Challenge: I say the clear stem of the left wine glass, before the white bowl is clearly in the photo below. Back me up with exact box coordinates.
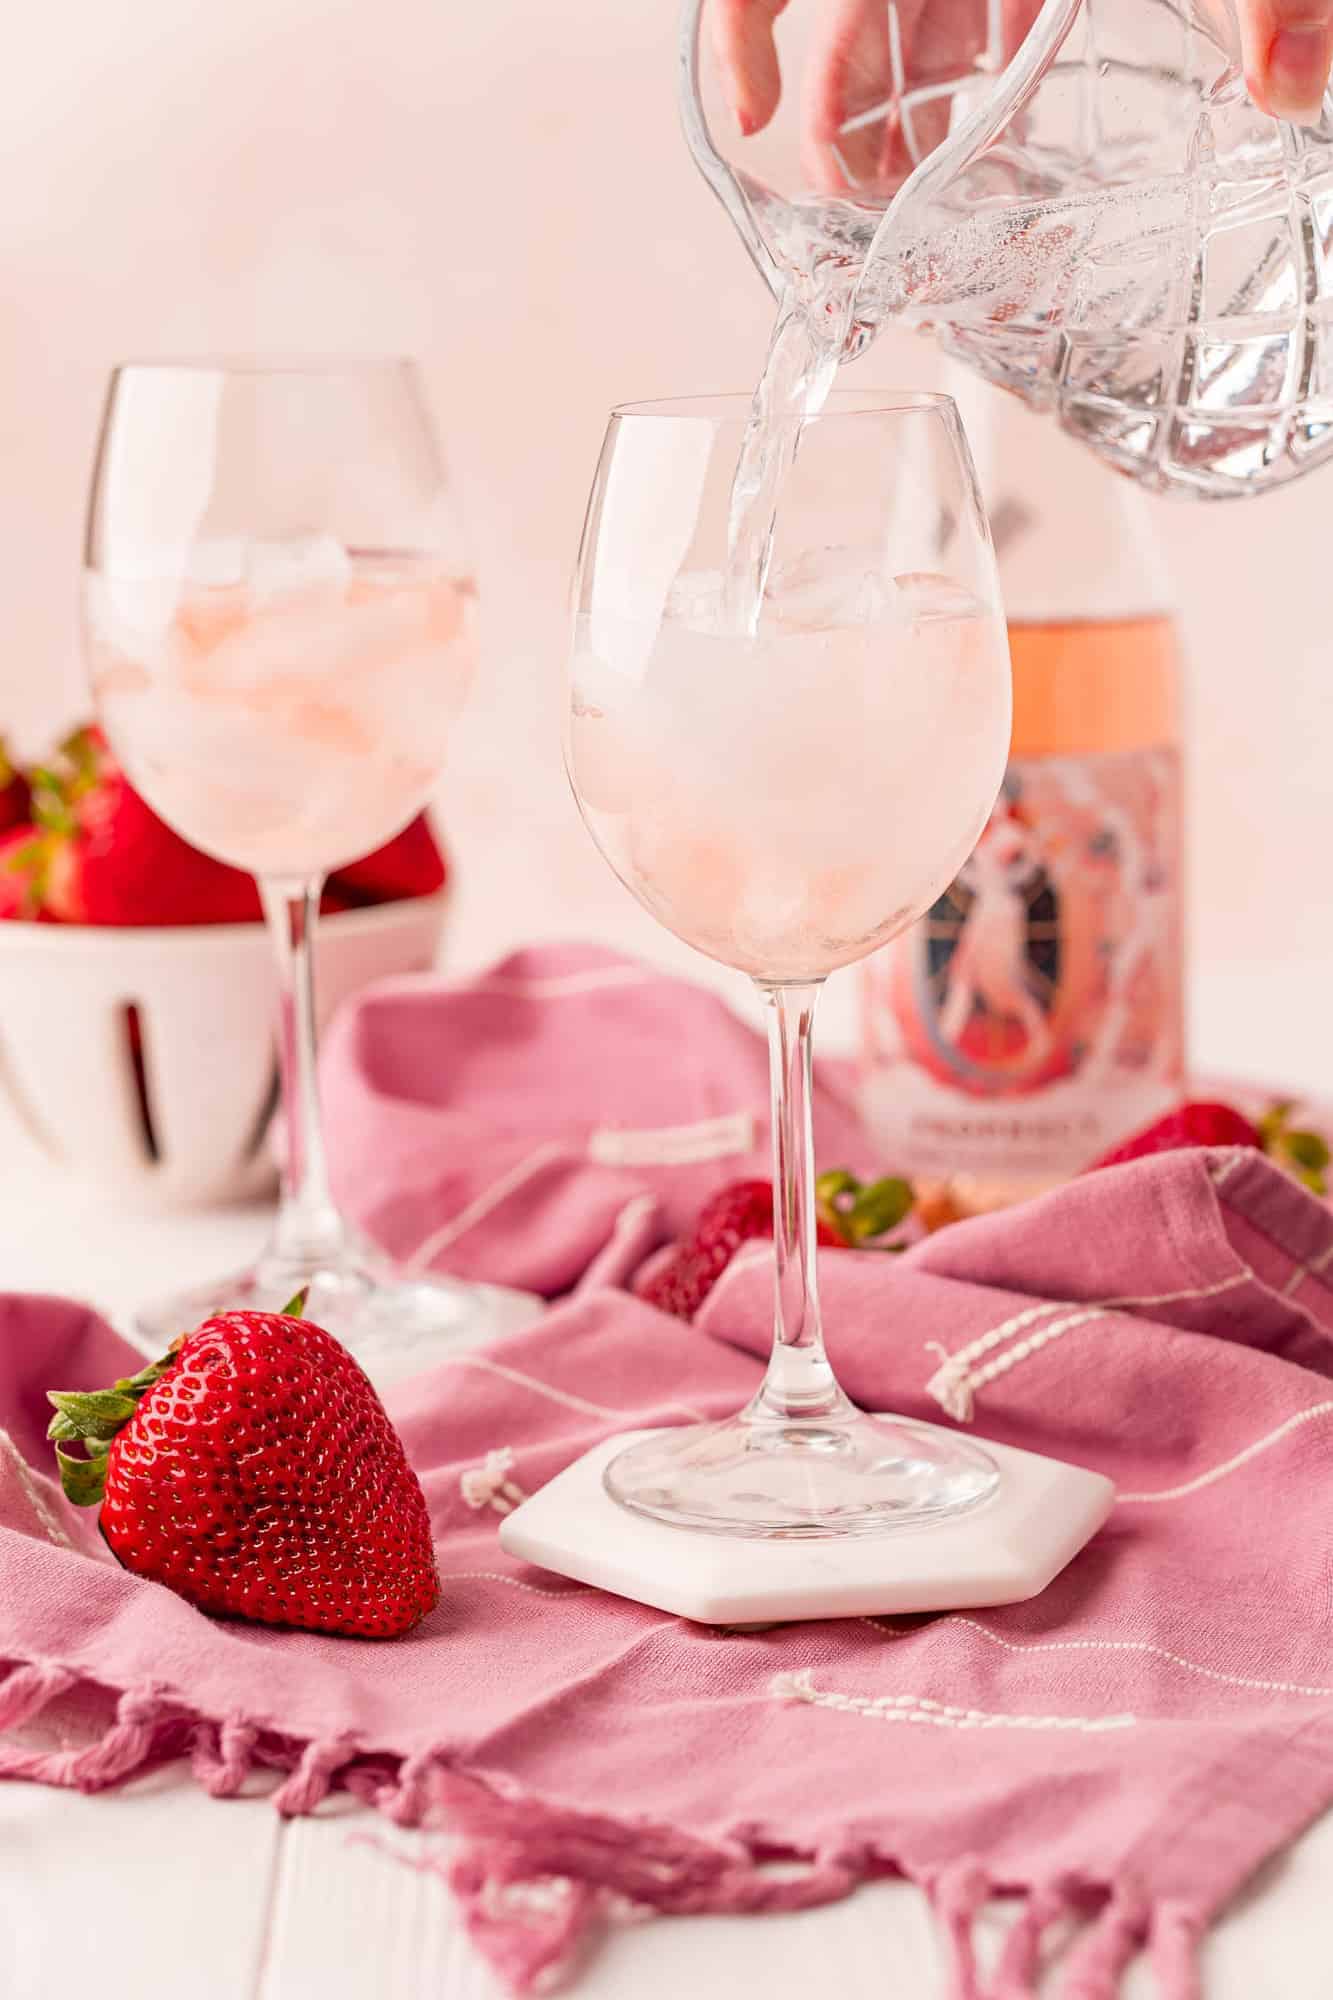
[260,876,346,1270]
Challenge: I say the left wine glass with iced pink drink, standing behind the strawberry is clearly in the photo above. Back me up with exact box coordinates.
[84,360,528,1376]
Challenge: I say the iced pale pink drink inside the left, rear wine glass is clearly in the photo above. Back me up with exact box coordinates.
[84,556,474,878]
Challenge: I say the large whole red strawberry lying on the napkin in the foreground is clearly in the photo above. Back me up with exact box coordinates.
[48,1298,440,1638]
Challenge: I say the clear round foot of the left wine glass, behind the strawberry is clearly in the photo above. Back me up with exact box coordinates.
[134,1246,542,1388]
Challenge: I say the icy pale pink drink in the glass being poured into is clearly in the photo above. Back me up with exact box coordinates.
[566,580,1011,980]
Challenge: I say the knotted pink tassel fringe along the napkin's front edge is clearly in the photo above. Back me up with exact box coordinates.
[0,1660,1203,2000]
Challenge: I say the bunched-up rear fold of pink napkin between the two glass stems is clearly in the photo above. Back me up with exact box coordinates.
[322,946,875,1298]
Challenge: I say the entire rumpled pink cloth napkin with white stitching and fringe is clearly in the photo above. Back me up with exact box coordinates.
[0,952,1333,2000]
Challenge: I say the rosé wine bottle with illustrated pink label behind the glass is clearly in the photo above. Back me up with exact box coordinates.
[863,374,1185,1212]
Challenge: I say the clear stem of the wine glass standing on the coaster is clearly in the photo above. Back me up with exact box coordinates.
[745,984,851,1422]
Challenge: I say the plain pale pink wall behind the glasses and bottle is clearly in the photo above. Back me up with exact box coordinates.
[0,0,1333,1074]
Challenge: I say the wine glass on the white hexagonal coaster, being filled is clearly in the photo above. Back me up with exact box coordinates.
[566,392,1011,1536]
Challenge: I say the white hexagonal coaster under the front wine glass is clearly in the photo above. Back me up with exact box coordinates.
[500,1430,1115,1626]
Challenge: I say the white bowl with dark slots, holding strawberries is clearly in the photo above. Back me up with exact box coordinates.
[0,892,448,1208]
